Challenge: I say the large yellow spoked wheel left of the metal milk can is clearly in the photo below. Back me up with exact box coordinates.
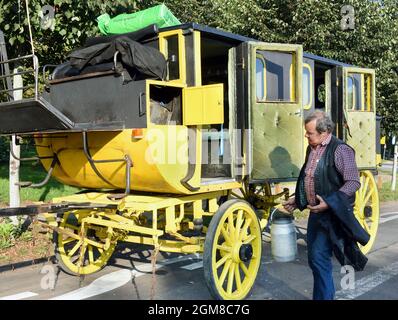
[203,199,261,300]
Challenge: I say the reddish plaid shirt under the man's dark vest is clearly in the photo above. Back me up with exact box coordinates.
[304,134,361,206]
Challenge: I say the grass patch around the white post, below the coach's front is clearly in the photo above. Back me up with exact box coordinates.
[0,163,80,205]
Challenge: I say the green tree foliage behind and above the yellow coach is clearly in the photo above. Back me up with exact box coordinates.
[0,0,398,132]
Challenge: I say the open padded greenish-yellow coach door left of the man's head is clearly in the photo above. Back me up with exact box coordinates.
[248,42,304,180]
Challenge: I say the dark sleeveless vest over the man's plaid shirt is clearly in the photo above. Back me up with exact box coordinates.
[295,136,355,210]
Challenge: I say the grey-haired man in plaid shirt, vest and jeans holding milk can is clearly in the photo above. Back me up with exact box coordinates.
[283,111,366,300]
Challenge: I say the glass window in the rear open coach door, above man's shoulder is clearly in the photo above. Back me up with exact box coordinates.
[347,73,373,111]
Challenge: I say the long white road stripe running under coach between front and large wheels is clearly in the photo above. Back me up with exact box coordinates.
[50,254,200,300]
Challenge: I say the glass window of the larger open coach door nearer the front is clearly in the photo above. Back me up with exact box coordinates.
[256,50,296,102]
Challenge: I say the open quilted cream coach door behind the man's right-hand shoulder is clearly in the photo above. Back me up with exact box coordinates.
[342,67,376,168]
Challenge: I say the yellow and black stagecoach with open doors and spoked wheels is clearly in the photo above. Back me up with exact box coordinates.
[0,23,379,299]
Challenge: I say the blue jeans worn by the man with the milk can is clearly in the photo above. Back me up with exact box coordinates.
[307,213,335,300]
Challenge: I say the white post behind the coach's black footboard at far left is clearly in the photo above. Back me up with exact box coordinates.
[10,68,23,225]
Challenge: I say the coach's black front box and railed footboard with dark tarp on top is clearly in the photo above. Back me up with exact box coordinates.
[0,25,167,135]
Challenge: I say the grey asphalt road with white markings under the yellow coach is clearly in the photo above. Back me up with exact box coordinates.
[0,202,398,300]
